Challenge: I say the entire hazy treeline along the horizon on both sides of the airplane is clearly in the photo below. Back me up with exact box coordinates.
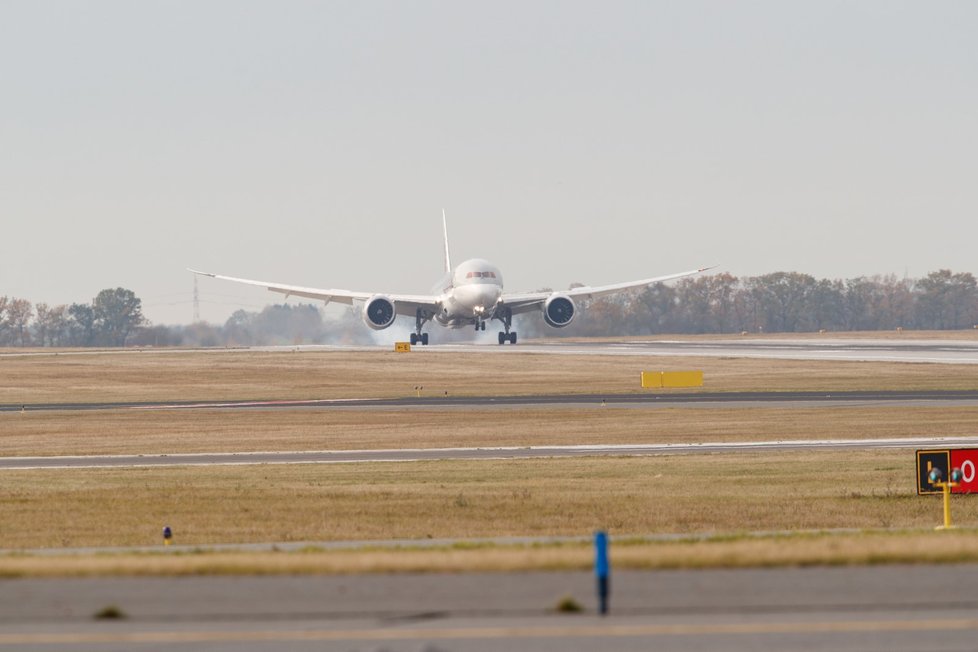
[0,270,978,347]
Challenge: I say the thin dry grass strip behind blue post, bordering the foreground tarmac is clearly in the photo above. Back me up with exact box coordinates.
[0,530,978,577]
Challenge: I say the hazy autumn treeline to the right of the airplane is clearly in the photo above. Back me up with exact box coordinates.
[520,269,978,337]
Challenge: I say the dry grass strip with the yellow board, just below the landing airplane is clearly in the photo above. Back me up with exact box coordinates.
[0,350,978,404]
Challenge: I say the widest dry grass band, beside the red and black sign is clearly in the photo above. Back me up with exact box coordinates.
[0,451,960,548]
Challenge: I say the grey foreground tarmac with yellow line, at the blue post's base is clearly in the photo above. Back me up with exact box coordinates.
[0,564,978,652]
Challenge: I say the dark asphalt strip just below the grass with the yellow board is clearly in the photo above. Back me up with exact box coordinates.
[0,390,978,412]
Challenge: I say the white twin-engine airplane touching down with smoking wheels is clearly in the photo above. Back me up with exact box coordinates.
[188,211,712,345]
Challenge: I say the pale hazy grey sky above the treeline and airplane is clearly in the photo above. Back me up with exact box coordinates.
[0,0,978,323]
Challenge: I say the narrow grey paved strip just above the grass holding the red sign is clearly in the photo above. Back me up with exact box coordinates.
[7,437,978,471]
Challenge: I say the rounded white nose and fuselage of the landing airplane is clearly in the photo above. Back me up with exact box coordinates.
[435,258,503,328]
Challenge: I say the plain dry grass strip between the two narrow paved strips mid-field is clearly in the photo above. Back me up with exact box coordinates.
[0,404,978,456]
